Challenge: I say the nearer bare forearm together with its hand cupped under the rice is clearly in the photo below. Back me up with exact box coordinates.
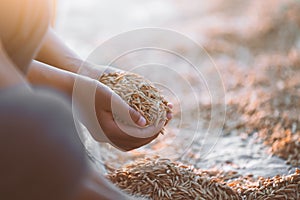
[27,61,162,150]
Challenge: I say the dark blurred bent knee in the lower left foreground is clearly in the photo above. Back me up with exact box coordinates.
[0,88,87,200]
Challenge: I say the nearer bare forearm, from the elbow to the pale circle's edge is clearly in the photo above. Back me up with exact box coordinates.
[27,61,77,96]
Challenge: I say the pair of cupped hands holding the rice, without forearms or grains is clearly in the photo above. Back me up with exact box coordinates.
[77,65,172,151]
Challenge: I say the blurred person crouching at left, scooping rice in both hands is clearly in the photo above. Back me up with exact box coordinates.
[0,0,171,200]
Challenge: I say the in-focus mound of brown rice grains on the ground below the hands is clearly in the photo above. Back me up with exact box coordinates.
[107,158,240,200]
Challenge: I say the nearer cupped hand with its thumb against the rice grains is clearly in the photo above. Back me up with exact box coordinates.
[95,83,169,151]
